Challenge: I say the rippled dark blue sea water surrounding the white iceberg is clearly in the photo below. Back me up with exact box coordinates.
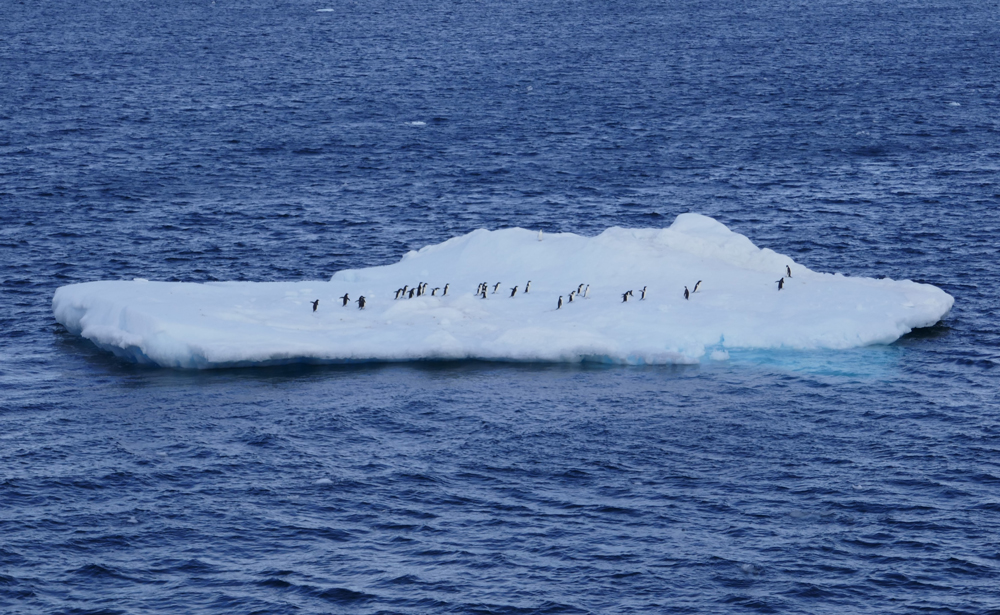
[0,0,1000,615]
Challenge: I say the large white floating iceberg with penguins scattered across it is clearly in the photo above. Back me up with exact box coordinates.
[52,214,954,368]
